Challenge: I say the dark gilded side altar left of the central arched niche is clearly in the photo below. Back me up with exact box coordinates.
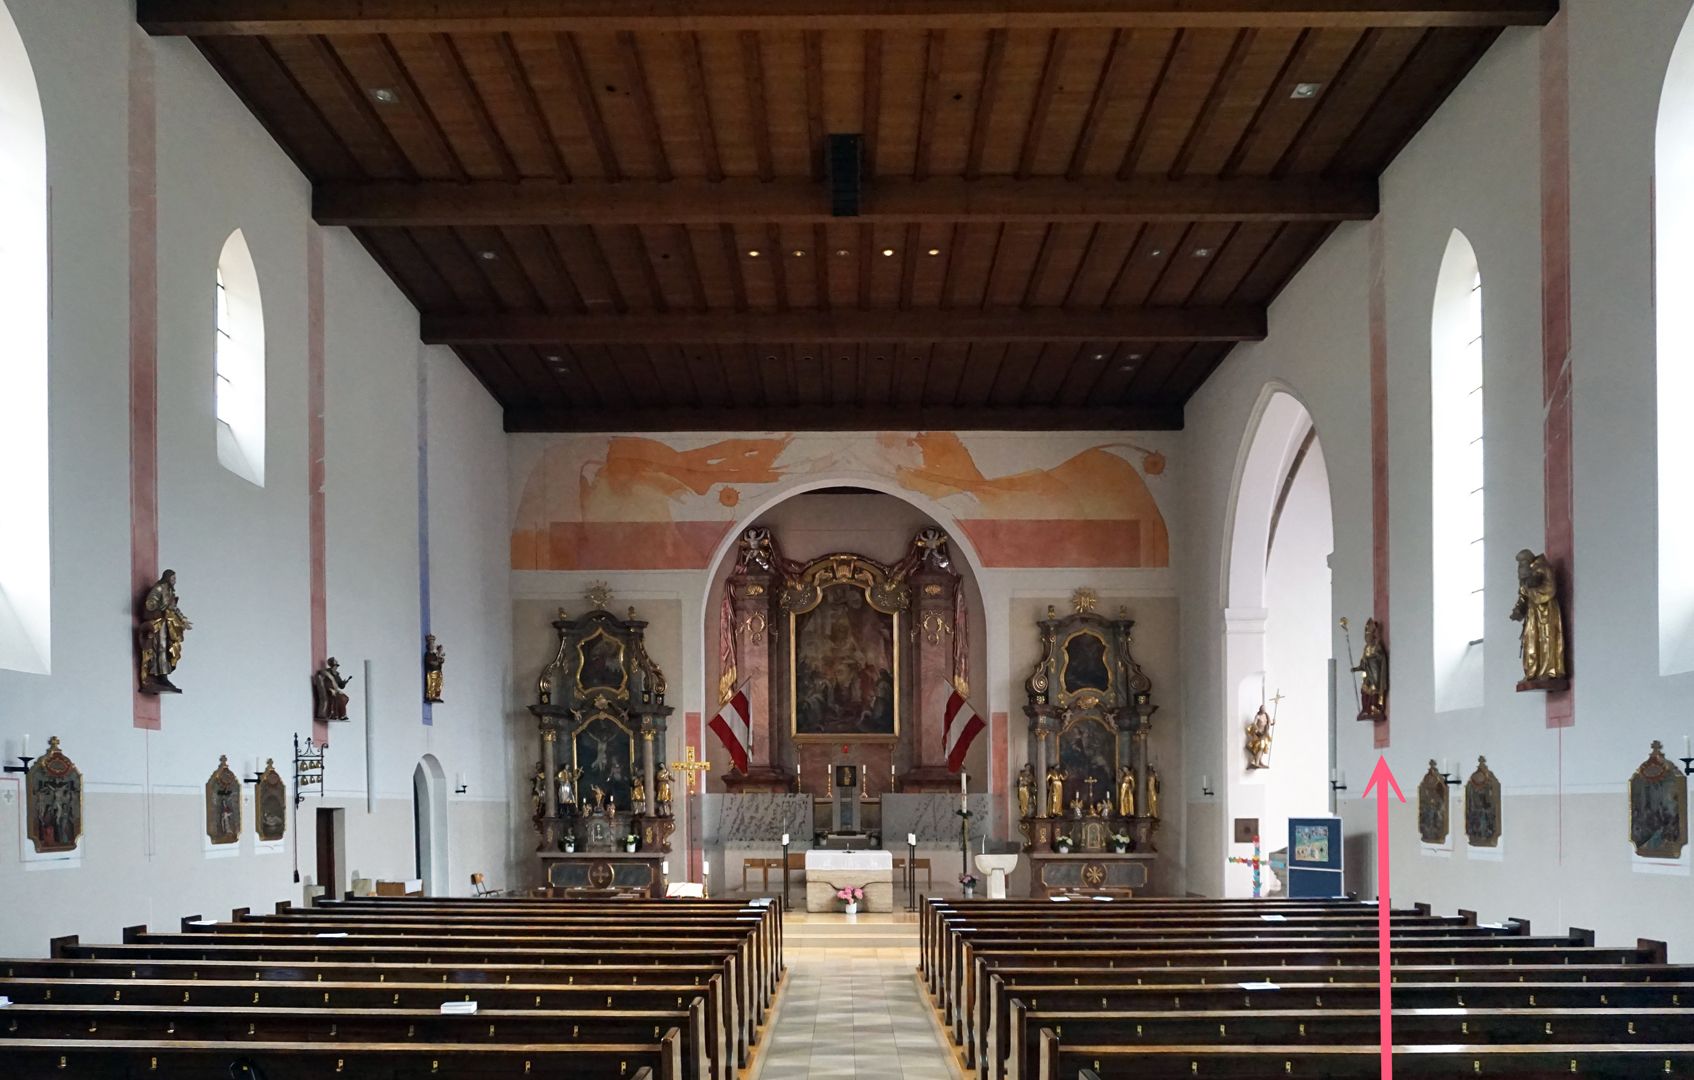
[529,587,676,895]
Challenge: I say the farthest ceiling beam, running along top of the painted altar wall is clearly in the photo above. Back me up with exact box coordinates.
[505,405,1182,432]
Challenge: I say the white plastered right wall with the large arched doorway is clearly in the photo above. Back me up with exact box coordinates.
[1182,0,1694,956]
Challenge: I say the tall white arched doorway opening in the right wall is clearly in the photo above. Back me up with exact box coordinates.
[1220,386,1335,895]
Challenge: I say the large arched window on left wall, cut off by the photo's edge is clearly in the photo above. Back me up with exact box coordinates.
[0,0,53,674]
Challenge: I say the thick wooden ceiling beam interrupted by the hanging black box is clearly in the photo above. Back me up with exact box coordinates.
[312,176,1377,227]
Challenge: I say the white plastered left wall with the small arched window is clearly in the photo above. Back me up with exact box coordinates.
[0,0,512,955]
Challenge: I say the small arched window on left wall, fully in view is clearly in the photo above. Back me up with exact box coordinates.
[215,229,264,488]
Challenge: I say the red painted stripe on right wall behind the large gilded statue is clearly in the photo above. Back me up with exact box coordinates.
[1542,12,1577,728]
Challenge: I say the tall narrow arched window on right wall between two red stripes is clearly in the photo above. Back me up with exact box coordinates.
[1430,229,1486,709]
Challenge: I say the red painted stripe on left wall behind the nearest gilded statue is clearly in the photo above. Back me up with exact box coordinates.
[129,29,163,731]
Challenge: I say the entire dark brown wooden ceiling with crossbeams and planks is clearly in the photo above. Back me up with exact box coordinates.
[137,0,1557,430]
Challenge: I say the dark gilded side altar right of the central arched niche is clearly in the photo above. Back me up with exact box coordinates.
[1018,589,1159,897]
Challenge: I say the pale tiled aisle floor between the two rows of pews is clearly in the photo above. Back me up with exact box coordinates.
[750,912,957,1080]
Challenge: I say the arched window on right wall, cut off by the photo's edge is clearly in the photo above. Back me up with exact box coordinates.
[1653,19,1694,675]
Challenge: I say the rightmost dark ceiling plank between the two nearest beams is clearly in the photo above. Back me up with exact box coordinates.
[1325,29,1497,176]
